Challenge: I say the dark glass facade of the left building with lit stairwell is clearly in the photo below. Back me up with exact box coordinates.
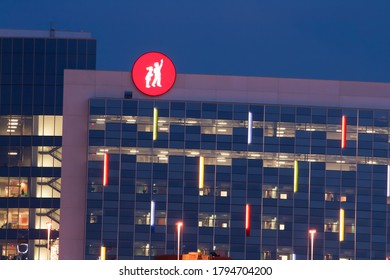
[0,36,96,259]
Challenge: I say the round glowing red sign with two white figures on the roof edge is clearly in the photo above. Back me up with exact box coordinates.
[131,52,176,96]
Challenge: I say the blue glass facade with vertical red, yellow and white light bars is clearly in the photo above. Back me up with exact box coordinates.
[85,98,390,260]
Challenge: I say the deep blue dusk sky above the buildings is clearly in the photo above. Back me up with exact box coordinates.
[0,0,390,82]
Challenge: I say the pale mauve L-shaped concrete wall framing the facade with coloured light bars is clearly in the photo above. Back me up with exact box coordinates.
[60,70,390,259]
